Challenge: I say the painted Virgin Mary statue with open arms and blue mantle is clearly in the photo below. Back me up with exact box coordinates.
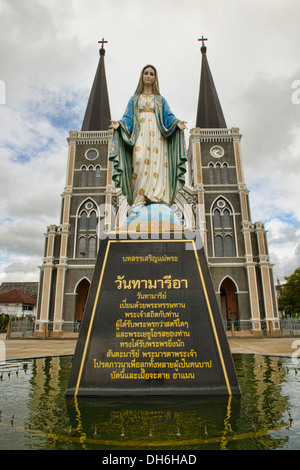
[109,65,187,206]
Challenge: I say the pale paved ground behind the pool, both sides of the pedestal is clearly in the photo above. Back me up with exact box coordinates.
[0,334,300,360]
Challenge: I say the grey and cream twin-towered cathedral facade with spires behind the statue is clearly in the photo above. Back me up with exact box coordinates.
[36,44,280,335]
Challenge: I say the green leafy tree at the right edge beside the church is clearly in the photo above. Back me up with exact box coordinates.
[278,268,300,317]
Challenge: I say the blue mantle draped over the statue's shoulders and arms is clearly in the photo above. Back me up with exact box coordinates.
[109,95,187,205]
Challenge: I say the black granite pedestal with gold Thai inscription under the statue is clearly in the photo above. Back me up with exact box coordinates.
[66,233,240,397]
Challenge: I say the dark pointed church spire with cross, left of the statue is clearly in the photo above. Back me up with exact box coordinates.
[81,39,111,131]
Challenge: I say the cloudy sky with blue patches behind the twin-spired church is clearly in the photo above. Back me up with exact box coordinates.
[0,0,300,283]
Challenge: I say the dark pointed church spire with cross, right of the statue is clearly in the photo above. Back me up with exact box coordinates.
[196,36,227,129]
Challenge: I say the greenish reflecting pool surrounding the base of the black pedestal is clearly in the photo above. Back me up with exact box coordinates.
[0,354,300,451]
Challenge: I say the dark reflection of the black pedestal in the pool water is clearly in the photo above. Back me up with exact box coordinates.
[68,397,237,448]
